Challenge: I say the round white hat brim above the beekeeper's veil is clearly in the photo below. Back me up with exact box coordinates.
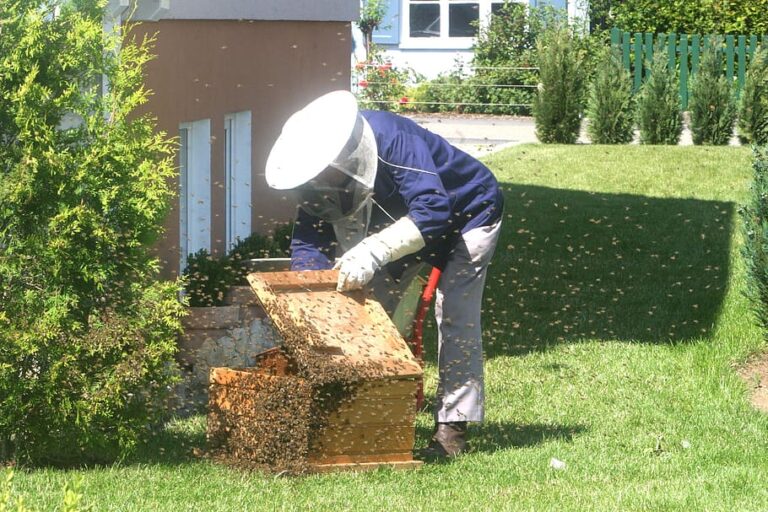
[266,91,358,190]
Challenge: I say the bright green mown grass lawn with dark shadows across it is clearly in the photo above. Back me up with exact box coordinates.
[6,145,768,512]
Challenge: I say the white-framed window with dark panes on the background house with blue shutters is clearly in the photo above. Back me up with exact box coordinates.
[403,0,516,48]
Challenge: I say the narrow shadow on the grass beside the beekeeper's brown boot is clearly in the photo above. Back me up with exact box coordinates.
[416,422,587,453]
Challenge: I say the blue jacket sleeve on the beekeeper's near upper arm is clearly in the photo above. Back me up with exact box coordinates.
[382,134,451,244]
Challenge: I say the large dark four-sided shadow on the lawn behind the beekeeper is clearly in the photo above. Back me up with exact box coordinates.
[425,184,735,360]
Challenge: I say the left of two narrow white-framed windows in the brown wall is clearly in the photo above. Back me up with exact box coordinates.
[179,119,211,271]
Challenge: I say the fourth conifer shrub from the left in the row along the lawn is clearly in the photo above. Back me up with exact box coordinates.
[688,38,736,146]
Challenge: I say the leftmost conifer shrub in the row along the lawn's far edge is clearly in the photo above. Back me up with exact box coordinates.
[533,27,586,144]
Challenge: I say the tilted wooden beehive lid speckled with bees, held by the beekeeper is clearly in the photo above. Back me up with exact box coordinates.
[248,270,422,380]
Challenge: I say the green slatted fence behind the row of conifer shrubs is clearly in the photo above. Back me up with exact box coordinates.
[611,28,768,108]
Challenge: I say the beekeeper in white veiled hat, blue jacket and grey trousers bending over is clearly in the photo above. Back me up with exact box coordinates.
[266,91,503,457]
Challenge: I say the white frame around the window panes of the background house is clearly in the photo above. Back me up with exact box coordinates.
[400,0,512,50]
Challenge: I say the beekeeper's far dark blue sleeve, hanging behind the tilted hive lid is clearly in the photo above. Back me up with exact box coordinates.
[291,208,336,270]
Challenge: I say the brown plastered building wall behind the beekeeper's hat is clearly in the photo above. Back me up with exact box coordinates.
[132,19,351,277]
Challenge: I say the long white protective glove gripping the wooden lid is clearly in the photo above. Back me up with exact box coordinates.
[333,217,425,292]
